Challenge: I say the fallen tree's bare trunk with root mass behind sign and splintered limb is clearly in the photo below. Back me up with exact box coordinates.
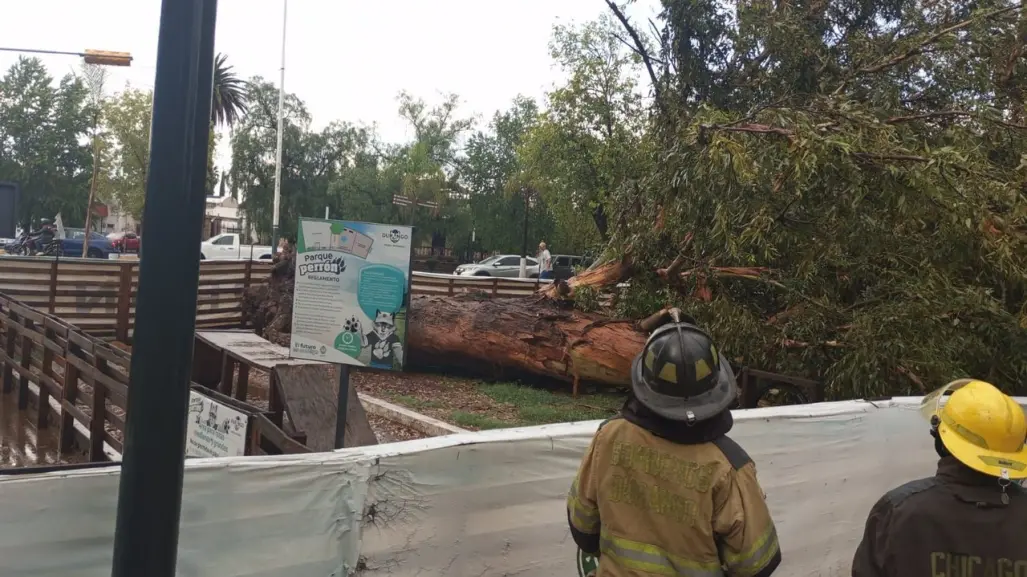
[242,251,646,391]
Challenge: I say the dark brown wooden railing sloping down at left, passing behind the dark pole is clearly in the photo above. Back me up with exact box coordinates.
[0,295,306,462]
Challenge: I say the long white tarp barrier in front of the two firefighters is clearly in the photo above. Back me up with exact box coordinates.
[0,399,1022,577]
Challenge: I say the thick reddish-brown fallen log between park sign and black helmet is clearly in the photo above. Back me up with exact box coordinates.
[407,295,645,389]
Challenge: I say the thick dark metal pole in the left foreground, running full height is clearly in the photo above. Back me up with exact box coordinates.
[112,0,217,577]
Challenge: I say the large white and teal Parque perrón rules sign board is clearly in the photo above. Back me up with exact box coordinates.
[290,219,413,371]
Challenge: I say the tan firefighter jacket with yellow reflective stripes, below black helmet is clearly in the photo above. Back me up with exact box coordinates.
[567,399,781,577]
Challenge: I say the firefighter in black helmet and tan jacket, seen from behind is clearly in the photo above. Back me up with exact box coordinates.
[567,311,781,577]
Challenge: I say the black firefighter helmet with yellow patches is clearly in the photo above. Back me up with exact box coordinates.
[632,322,738,424]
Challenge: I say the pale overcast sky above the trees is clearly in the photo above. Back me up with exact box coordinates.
[0,0,656,142]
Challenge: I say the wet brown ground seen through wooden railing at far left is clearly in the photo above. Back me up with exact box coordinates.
[0,393,62,468]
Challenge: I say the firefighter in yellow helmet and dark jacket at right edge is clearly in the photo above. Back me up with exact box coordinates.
[852,379,1027,577]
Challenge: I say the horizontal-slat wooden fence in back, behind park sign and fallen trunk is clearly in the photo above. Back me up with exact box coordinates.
[0,256,548,342]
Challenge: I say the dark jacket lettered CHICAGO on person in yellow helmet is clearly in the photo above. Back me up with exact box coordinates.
[852,456,1027,577]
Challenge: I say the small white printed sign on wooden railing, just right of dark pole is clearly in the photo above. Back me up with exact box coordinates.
[186,390,250,457]
